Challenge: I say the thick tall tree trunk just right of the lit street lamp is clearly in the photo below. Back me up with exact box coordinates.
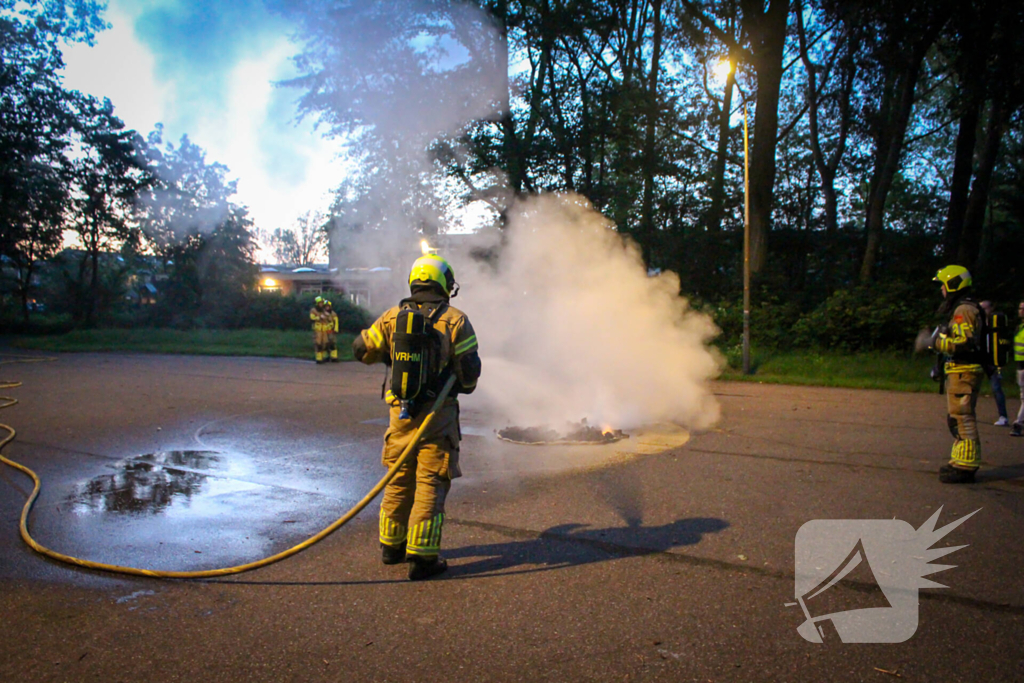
[740,0,790,274]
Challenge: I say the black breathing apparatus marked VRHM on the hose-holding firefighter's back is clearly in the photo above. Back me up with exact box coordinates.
[391,303,446,420]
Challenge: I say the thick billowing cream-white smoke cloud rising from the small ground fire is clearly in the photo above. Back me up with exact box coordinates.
[454,195,722,428]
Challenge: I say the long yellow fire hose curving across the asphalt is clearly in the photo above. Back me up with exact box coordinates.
[0,357,456,579]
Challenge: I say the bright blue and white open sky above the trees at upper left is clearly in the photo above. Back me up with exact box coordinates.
[65,0,352,235]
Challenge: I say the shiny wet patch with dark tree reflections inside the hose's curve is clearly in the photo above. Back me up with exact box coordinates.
[34,451,364,570]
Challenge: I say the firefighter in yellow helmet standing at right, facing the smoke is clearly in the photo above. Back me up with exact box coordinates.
[933,265,986,483]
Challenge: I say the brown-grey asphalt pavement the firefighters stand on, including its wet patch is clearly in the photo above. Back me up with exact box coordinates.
[0,354,1024,683]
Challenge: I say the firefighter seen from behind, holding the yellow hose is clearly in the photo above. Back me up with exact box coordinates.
[352,254,480,581]
